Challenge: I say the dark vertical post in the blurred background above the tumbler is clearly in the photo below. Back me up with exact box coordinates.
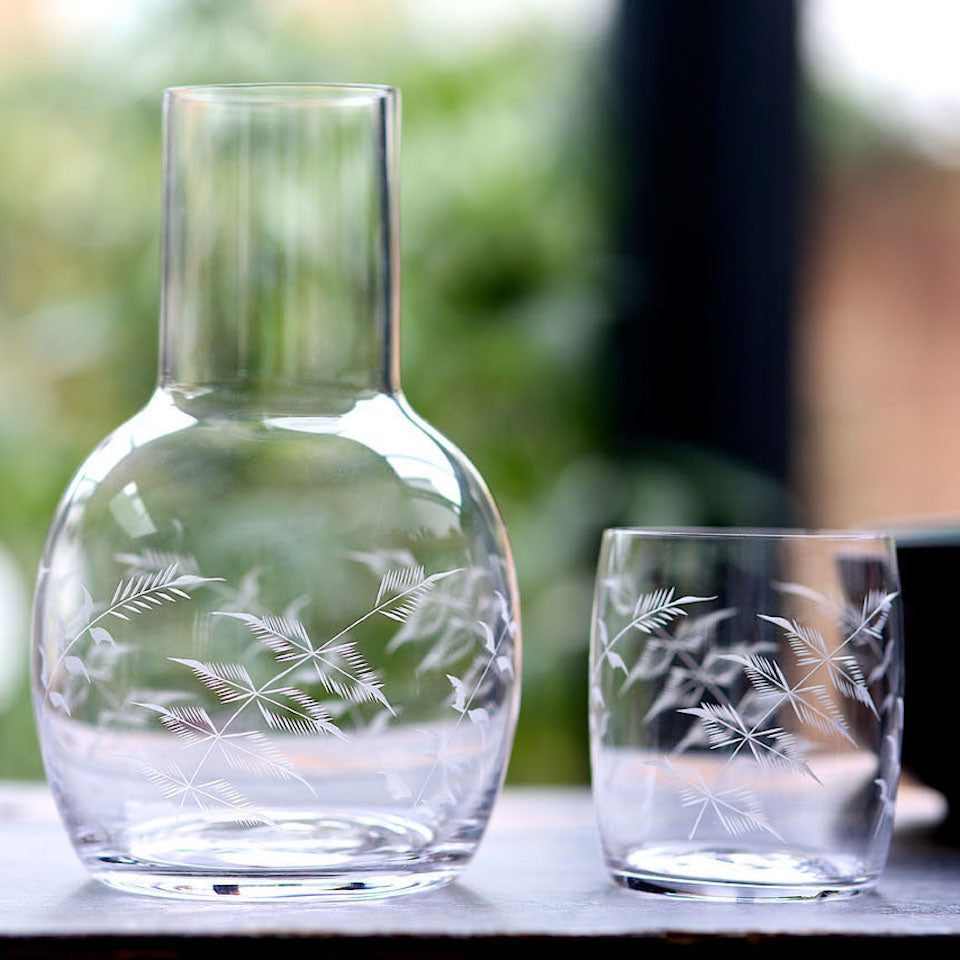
[612,0,799,510]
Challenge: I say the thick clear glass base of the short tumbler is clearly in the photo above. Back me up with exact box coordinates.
[609,845,876,902]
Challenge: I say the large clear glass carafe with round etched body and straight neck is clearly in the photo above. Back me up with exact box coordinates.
[33,84,520,899]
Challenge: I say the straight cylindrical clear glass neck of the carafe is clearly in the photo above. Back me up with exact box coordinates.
[160,84,400,402]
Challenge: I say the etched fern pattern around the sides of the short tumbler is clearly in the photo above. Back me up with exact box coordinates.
[590,582,902,840]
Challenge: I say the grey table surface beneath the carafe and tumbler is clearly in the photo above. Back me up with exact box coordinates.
[0,784,960,957]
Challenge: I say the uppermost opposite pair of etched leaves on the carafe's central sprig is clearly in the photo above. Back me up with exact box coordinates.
[213,610,392,710]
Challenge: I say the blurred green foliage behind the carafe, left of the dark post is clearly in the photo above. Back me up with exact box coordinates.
[0,0,619,782]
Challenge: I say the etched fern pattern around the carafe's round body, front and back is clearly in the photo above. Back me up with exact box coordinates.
[40,550,516,825]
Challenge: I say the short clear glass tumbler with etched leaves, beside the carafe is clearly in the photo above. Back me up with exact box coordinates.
[590,529,903,900]
